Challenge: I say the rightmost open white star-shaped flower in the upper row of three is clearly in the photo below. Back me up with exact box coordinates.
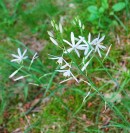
[92,35,106,57]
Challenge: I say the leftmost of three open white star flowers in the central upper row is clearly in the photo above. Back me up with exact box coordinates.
[63,32,84,57]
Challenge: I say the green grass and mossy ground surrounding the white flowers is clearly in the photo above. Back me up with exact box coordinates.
[0,0,130,133]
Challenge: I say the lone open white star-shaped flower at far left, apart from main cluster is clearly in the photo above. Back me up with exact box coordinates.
[11,48,28,63]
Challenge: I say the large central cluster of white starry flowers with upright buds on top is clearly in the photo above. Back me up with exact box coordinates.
[48,18,111,83]
